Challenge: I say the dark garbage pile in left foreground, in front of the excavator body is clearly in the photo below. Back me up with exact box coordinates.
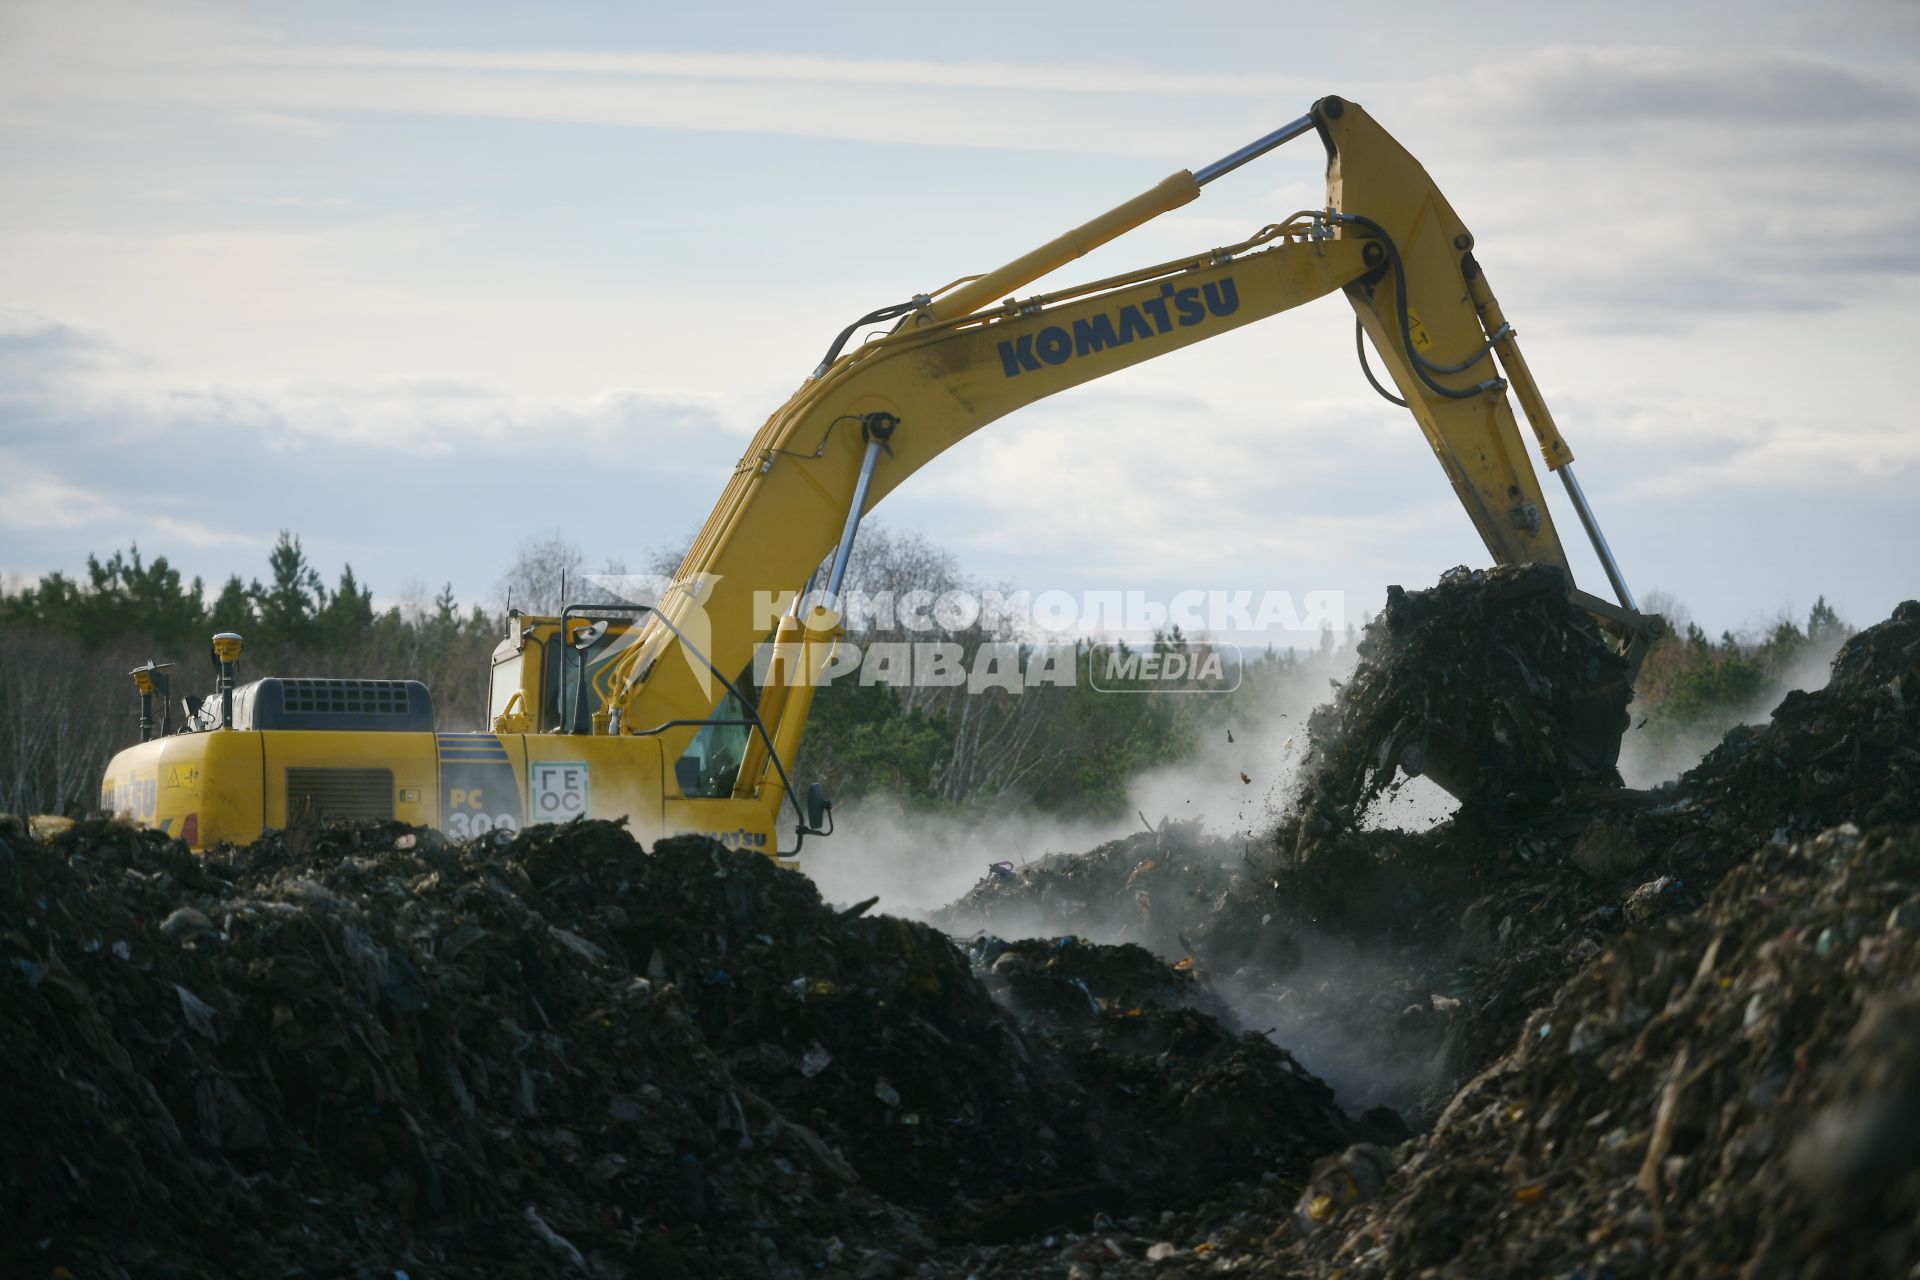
[0,819,1382,1276]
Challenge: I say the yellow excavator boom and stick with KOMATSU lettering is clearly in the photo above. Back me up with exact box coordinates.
[595,98,1642,844]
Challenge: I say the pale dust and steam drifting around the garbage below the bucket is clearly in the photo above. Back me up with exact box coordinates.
[803,614,1841,1111]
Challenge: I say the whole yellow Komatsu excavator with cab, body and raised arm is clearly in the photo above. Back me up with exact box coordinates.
[102,96,1661,858]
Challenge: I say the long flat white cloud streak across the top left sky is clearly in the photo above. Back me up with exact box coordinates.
[0,6,1311,154]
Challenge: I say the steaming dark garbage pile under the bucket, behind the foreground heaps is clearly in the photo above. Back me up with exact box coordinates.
[935,594,1920,1125]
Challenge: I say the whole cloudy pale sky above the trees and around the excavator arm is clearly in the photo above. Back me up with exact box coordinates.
[0,0,1920,629]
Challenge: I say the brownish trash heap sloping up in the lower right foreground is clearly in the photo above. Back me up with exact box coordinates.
[1282,825,1920,1278]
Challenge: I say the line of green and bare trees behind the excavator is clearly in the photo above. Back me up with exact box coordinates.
[0,526,1849,818]
